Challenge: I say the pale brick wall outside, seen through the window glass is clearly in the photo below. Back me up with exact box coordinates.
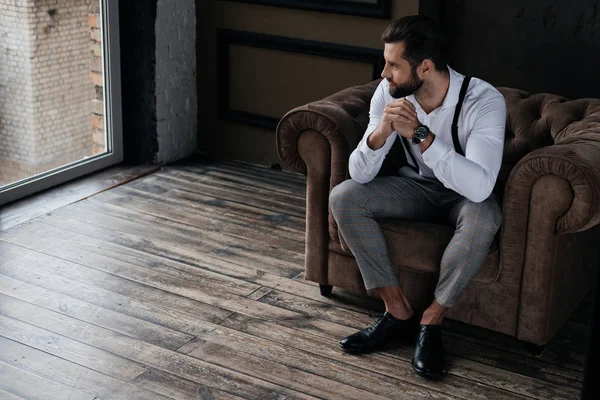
[0,0,98,184]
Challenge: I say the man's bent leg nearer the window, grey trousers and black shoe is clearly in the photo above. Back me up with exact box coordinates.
[329,177,435,352]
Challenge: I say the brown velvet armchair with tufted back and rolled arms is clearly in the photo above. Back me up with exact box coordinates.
[276,81,600,345]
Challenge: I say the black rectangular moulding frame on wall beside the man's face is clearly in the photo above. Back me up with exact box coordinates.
[217,29,385,129]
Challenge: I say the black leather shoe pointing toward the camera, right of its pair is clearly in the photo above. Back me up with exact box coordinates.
[412,325,444,378]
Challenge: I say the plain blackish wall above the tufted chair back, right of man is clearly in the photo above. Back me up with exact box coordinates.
[441,0,600,98]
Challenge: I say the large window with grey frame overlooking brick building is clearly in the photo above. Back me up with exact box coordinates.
[0,0,123,205]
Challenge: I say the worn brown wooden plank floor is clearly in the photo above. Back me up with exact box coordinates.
[0,163,589,400]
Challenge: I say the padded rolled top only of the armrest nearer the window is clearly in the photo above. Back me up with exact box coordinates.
[276,81,379,188]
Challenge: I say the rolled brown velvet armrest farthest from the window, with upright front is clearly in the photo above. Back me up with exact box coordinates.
[500,138,600,344]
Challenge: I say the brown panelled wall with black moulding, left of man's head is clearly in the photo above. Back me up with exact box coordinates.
[196,0,422,166]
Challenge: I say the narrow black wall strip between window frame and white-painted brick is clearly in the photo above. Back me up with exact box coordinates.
[119,0,158,164]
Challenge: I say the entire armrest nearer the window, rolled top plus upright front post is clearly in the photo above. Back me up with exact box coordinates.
[276,81,379,284]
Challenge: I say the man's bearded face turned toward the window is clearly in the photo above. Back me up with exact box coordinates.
[381,42,423,99]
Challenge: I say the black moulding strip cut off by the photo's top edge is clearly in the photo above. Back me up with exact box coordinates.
[227,0,392,19]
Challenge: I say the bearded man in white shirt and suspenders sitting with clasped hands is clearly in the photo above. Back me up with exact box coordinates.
[329,16,506,377]
